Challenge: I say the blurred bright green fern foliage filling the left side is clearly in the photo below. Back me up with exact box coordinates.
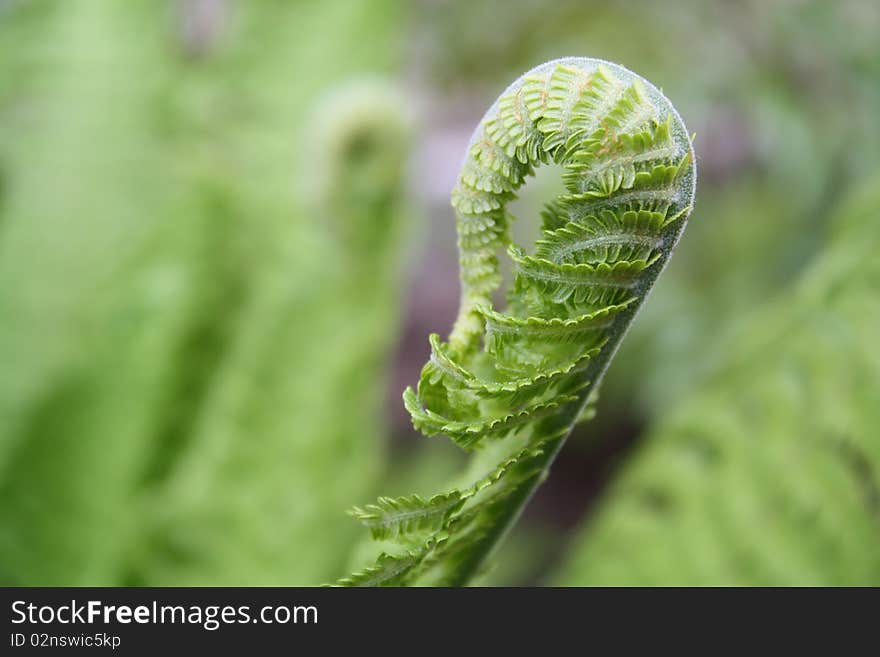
[0,0,407,585]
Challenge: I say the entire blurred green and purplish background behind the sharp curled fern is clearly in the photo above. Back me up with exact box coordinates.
[0,0,880,585]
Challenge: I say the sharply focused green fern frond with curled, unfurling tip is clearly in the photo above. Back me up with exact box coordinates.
[339,58,696,585]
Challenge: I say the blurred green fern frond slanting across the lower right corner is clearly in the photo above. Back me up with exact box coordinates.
[557,176,880,585]
